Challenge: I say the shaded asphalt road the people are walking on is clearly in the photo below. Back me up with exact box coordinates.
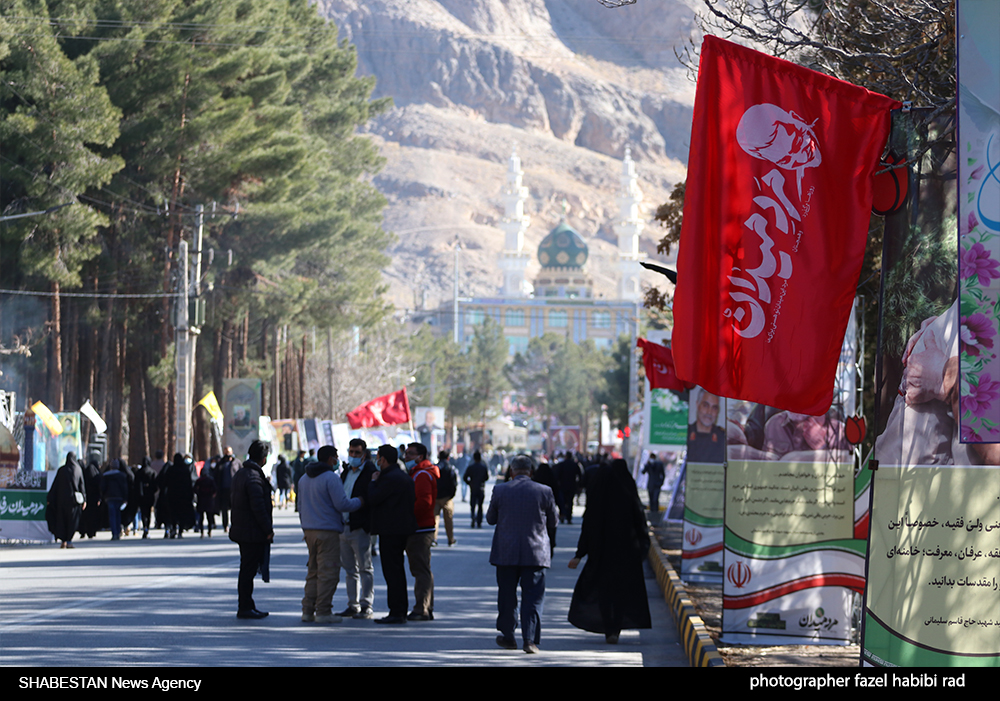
[0,482,687,667]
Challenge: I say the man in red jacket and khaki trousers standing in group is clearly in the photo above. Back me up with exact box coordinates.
[403,443,441,621]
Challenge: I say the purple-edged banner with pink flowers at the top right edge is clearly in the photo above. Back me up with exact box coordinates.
[958,0,1000,443]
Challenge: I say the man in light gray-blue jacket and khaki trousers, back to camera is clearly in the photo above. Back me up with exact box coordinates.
[295,445,364,623]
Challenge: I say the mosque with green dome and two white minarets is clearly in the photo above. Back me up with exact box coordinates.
[456,148,645,355]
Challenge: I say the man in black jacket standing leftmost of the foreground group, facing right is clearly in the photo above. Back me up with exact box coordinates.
[229,441,274,619]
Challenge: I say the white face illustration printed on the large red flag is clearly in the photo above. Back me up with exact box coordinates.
[736,103,823,173]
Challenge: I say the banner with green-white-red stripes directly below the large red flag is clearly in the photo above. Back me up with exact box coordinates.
[722,318,869,645]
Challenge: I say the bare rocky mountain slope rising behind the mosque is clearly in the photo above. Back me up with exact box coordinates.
[318,0,698,309]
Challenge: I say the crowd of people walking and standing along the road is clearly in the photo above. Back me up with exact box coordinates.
[47,439,649,653]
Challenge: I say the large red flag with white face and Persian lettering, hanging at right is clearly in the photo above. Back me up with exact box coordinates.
[673,36,900,415]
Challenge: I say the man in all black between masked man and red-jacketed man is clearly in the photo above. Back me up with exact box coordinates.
[367,445,417,624]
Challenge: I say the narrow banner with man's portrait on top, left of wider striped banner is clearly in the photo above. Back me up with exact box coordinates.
[681,387,726,582]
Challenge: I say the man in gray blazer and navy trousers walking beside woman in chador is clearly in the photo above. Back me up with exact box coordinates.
[486,455,556,653]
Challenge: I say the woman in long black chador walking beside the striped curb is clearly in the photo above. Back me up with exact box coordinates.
[569,460,652,643]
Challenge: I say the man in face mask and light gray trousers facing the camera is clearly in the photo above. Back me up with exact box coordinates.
[340,438,376,618]
